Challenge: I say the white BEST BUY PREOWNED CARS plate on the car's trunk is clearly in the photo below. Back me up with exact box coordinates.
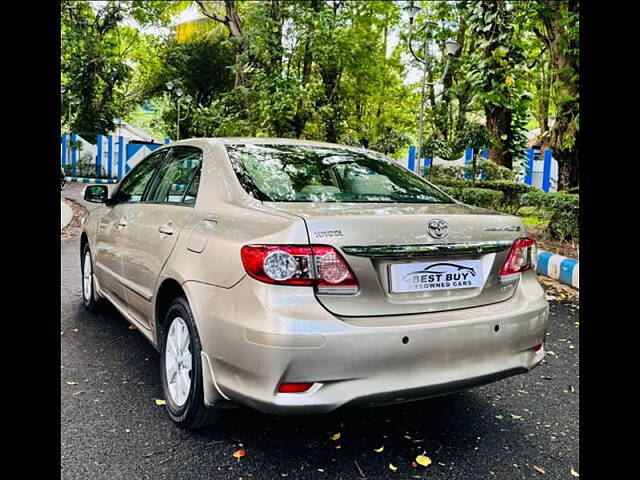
[389,260,484,293]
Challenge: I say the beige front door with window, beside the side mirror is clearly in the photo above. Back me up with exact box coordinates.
[93,150,166,306]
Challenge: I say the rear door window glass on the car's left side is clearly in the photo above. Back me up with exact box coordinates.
[146,147,202,205]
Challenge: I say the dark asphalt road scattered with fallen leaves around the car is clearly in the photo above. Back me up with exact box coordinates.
[61,185,579,480]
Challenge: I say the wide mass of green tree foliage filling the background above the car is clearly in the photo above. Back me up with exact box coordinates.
[61,0,579,180]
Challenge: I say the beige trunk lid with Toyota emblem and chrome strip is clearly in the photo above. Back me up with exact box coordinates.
[265,202,523,316]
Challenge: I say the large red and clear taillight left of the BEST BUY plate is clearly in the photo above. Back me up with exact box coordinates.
[240,245,358,295]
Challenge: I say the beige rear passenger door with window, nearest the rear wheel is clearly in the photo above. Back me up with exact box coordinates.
[123,146,202,328]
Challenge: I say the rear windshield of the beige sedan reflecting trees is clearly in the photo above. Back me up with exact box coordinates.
[227,145,453,203]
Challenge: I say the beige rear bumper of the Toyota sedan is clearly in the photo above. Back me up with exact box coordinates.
[182,272,548,414]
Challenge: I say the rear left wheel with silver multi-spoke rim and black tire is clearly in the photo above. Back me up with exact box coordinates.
[160,297,220,429]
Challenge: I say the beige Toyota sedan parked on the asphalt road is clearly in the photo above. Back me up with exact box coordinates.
[81,138,548,428]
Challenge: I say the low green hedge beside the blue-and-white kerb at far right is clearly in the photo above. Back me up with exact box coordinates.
[524,190,580,240]
